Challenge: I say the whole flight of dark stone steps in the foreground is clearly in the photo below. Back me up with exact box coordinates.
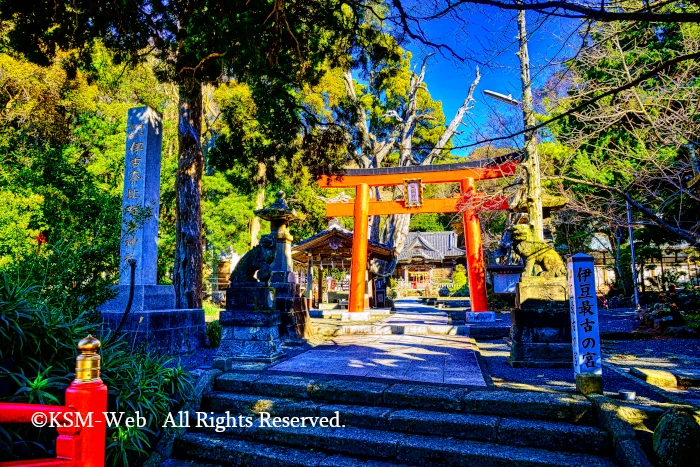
[163,372,616,467]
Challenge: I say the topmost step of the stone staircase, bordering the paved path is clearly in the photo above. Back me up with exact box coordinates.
[215,372,594,423]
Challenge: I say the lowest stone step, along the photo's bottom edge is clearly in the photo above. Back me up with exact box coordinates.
[175,427,615,467]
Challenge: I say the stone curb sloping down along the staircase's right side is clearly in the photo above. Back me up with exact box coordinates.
[586,394,652,467]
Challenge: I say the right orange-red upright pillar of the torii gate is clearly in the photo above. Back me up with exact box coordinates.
[461,178,489,311]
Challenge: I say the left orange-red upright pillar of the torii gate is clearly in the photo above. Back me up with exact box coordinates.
[348,183,369,313]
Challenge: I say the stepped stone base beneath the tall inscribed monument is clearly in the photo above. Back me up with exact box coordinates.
[100,285,205,355]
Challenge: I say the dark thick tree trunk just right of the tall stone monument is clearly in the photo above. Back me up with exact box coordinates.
[173,83,204,309]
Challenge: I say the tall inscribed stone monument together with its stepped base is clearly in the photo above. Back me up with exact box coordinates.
[100,107,205,354]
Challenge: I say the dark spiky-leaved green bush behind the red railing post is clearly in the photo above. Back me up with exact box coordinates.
[0,274,192,466]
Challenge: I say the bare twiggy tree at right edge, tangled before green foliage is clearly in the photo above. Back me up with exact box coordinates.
[549,18,700,247]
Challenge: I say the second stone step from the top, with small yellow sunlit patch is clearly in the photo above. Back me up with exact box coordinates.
[203,392,610,454]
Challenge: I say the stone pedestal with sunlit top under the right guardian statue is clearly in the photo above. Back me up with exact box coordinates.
[507,277,571,368]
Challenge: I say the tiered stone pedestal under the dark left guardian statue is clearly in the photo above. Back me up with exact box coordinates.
[213,282,284,370]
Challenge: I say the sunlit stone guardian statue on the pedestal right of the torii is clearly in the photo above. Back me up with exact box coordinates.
[510,224,566,277]
